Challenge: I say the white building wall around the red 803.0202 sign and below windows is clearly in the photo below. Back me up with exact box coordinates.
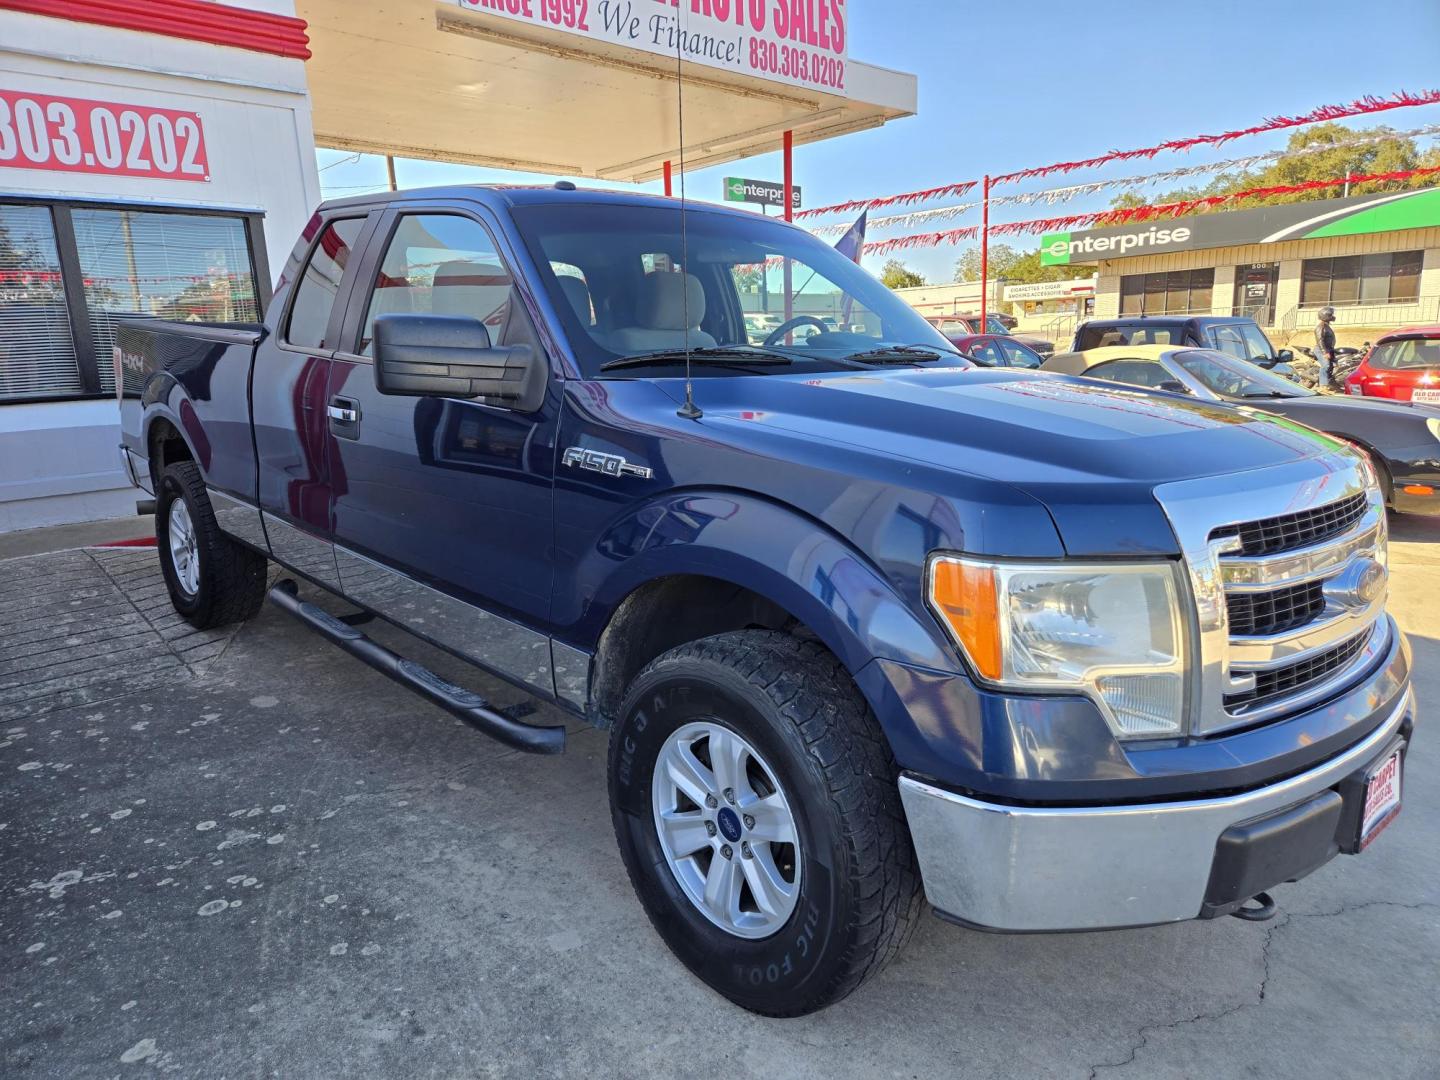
[0,8,321,531]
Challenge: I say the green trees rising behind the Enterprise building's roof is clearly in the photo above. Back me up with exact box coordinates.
[1110,124,1440,209]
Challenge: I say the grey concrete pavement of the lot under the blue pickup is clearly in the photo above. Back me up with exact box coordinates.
[0,521,1440,1080]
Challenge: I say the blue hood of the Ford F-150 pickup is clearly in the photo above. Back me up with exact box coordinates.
[694,367,1344,556]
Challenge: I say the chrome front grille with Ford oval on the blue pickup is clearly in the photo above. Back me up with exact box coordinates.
[1156,454,1390,736]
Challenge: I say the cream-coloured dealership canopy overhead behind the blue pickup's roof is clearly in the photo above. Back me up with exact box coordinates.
[297,0,916,181]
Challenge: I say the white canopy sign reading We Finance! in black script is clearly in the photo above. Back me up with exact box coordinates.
[455,0,850,95]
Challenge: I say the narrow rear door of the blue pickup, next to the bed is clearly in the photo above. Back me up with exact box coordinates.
[251,213,377,588]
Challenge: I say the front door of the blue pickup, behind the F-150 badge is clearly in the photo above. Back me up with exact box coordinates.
[327,207,559,694]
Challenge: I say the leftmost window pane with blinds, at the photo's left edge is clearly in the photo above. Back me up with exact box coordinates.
[0,204,81,402]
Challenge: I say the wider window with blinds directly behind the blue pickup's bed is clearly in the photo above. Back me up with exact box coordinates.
[71,207,261,392]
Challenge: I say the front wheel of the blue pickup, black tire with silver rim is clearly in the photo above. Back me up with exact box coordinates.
[609,631,922,1017]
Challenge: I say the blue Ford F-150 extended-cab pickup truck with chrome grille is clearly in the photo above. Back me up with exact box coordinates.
[115,183,1414,1015]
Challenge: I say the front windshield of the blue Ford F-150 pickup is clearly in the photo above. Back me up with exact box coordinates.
[514,203,969,377]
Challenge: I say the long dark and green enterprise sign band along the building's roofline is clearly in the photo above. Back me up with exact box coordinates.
[1040,187,1440,266]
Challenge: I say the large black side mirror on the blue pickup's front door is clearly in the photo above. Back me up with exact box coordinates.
[374,314,536,402]
